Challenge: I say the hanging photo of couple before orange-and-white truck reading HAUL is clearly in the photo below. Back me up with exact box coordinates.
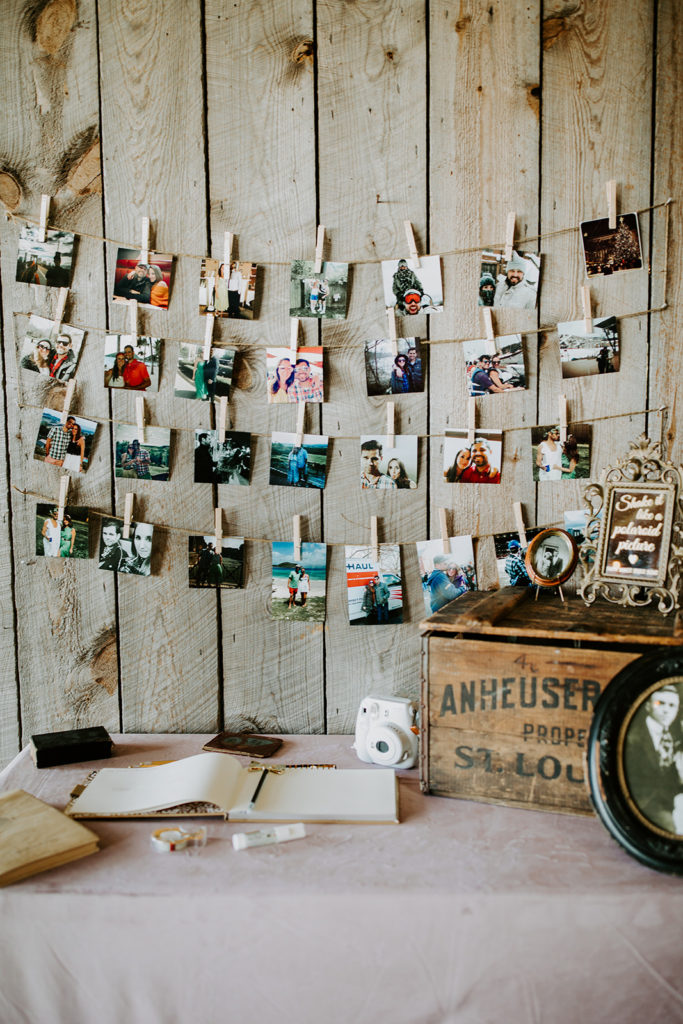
[344,544,403,626]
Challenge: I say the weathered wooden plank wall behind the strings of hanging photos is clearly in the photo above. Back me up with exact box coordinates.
[0,0,683,762]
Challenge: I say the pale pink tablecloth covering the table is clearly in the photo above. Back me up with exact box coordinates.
[0,735,683,1024]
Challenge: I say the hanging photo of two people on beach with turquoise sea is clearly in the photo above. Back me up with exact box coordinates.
[270,541,328,623]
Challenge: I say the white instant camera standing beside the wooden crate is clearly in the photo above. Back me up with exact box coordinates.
[353,696,419,768]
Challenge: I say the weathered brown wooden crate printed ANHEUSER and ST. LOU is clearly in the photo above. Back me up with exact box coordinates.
[420,587,683,814]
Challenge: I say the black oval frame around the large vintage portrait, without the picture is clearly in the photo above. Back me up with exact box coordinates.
[588,647,683,874]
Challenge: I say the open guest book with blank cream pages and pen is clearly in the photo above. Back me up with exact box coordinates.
[66,754,398,824]
